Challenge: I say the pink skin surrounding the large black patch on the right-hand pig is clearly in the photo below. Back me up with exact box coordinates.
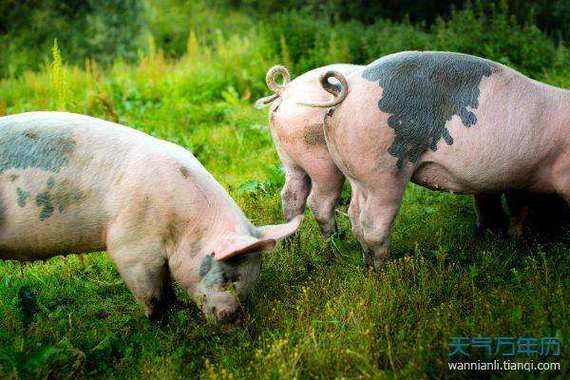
[316,52,570,267]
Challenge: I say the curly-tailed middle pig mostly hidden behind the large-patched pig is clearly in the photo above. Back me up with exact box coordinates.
[256,64,362,238]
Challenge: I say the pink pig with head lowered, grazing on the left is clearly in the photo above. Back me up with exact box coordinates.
[0,112,301,321]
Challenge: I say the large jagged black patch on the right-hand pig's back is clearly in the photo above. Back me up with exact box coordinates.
[362,52,498,168]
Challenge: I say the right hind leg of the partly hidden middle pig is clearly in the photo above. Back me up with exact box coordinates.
[309,176,344,239]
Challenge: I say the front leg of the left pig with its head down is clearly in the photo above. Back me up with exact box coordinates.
[109,241,174,320]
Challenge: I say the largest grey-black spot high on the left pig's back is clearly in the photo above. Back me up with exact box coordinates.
[0,125,76,174]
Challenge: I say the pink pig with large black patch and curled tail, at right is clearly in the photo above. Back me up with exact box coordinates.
[304,51,570,268]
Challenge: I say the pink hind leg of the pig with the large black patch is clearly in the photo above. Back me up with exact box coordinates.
[360,173,409,270]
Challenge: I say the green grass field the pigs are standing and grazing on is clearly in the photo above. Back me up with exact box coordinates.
[0,31,570,379]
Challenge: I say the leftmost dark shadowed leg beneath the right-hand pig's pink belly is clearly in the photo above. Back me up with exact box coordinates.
[474,193,508,236]
